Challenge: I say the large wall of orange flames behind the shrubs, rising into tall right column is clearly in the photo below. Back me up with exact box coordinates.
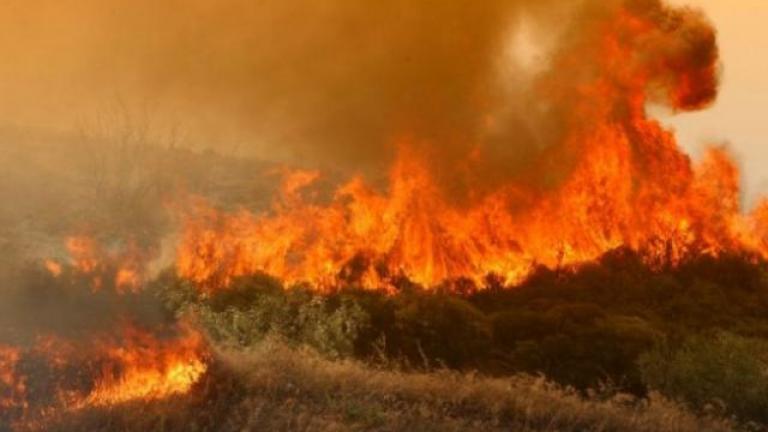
[176,1,768,290]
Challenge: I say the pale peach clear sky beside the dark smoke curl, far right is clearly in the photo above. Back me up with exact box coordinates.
[669,0,768,205]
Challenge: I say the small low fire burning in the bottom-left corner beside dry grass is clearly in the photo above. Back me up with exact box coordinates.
[0,325,208,424]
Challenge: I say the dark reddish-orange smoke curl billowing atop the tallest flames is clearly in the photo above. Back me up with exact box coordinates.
[547,0,720,111]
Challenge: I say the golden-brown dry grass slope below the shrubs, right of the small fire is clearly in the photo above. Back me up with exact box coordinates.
[214,341,732,431]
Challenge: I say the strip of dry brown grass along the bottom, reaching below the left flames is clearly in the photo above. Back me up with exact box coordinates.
[30,339,734,432]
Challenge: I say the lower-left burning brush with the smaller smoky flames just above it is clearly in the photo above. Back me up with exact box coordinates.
[0,236,210,430]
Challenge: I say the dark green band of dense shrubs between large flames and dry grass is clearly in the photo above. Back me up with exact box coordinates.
[153,251,768,421]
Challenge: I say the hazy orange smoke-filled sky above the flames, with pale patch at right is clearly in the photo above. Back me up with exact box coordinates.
[0,0,768,203]
